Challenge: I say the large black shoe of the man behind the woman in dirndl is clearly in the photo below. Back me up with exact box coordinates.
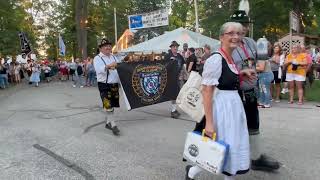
[251,154,280,171]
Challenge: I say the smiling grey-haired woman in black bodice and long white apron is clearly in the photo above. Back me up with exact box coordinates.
[186,22,256,180]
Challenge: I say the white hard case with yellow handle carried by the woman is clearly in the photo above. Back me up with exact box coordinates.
[183,132,229,174]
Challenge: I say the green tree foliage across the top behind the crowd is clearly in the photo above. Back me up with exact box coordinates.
[0,0,320,59]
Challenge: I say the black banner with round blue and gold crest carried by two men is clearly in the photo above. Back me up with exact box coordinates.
[117,61,179,109]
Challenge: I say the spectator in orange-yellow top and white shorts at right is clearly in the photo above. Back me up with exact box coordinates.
[284,44,308,105]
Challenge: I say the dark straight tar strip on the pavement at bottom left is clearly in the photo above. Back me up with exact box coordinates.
[33,144,95,180]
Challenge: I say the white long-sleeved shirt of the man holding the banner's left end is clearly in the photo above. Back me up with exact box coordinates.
[93,53,120,84]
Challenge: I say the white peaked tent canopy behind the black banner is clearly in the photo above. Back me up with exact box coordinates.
[121,28,220,53]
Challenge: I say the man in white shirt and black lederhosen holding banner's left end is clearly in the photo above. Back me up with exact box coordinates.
[93,38,120,136]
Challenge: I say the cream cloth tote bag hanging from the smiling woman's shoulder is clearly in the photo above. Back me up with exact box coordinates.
[176,71,204,122]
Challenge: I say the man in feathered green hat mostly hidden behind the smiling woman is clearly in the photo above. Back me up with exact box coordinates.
[230,10,280,171]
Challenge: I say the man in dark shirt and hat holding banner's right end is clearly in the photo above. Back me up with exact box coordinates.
[164,41,185,119]
